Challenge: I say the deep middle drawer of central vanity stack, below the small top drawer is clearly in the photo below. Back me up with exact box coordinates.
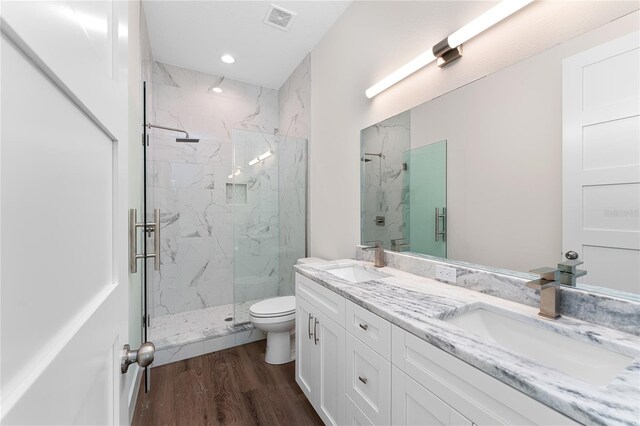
[345,333,391,425]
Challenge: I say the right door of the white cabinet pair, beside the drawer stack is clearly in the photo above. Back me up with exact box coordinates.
[314,311,345,425]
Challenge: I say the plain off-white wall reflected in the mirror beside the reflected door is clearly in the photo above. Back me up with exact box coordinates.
[411,12,640,271]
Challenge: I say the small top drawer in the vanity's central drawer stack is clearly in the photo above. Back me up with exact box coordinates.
[345,301,391,360]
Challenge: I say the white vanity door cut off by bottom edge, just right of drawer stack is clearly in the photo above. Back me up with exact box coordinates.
[391,366,472,426]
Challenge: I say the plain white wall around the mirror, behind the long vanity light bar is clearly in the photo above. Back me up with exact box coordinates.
[310,1,638,258]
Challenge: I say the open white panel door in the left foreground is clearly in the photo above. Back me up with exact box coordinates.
[0,1,128,425]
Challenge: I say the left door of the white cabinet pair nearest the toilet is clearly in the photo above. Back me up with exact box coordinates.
[296,297,319,402]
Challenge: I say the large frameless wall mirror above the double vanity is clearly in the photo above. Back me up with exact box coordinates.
[360,12,640,299]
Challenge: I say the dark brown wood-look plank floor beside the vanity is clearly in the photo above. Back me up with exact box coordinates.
[132,340,323,426]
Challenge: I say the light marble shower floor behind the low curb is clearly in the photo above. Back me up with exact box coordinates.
[149,300,258,349]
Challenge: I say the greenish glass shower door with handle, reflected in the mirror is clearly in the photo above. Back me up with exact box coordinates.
[407,141,447,258]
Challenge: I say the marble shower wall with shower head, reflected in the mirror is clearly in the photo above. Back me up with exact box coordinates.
[361,111,411,249]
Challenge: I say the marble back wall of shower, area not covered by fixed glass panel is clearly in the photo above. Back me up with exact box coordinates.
[148,62,278,316]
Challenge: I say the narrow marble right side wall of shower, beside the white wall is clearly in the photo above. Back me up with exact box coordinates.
[278,55,311,296]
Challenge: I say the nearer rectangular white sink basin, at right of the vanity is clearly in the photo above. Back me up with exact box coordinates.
[445,307,633,386]
